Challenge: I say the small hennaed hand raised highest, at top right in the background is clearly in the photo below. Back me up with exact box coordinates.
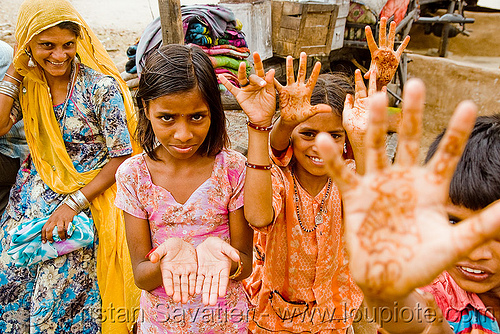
[365,17,410,90]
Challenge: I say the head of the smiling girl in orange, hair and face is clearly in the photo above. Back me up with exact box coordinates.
[291,73,354,176]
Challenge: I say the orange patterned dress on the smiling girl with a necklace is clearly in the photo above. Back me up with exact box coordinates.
[244,149,363,333]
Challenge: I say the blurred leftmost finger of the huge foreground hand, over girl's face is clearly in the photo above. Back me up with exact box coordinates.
[316,133,358,192]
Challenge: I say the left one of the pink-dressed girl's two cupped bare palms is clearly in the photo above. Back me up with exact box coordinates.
[149,238,198,304]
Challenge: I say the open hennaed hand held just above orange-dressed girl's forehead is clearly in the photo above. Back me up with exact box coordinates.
[275,52,332,127]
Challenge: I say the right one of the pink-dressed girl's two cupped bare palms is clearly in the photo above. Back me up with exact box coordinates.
[196,237,240,306]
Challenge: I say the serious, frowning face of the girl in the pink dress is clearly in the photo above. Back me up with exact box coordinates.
[147,88,211,160]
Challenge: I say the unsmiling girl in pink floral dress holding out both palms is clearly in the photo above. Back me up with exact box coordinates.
[116,45,253,334]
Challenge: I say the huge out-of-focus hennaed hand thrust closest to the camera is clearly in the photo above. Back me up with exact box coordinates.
[316,79,500,302]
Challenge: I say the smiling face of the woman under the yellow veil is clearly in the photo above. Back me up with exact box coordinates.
[28,26,77,78]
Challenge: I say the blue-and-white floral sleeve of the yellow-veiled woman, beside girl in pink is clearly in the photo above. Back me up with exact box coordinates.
[93,76,132,158]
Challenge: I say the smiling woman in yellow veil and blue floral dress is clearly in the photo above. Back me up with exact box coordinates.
[0,0,139,333]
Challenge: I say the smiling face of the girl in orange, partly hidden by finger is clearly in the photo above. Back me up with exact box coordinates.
[292,112,345,178]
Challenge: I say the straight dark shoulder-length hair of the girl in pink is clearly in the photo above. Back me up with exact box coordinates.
[136,44,229,159]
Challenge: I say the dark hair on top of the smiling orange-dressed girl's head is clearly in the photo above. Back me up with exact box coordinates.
[311,72,354,116]
